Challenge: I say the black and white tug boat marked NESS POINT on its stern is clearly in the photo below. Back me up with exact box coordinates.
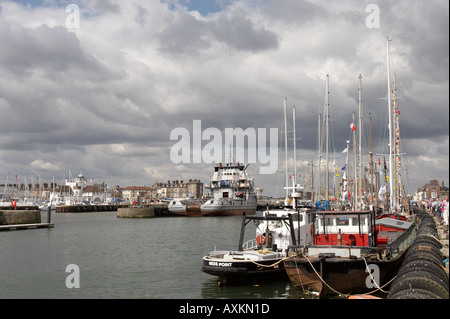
[202,199,314,283]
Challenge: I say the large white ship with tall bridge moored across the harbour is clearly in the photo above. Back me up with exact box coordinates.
[200,163,257,216]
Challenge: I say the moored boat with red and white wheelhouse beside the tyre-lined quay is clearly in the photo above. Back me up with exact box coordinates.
[284,211,417,298]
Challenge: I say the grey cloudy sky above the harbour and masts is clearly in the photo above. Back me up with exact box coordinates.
[0,0,449,199]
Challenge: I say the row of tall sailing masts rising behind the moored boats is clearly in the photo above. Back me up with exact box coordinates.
[284,39,405,212]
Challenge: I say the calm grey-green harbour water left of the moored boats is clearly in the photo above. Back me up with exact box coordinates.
[0,212,304,299]
